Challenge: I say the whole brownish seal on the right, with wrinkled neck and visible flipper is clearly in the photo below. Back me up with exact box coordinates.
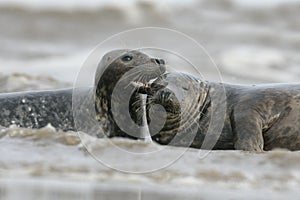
[147,73,300,151]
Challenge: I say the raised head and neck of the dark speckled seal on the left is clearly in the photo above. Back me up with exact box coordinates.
[95,49,166,138]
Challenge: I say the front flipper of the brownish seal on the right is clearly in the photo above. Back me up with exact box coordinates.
[231,108,264,152]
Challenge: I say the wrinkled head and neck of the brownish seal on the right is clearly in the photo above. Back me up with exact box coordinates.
[147,73,208,146]
